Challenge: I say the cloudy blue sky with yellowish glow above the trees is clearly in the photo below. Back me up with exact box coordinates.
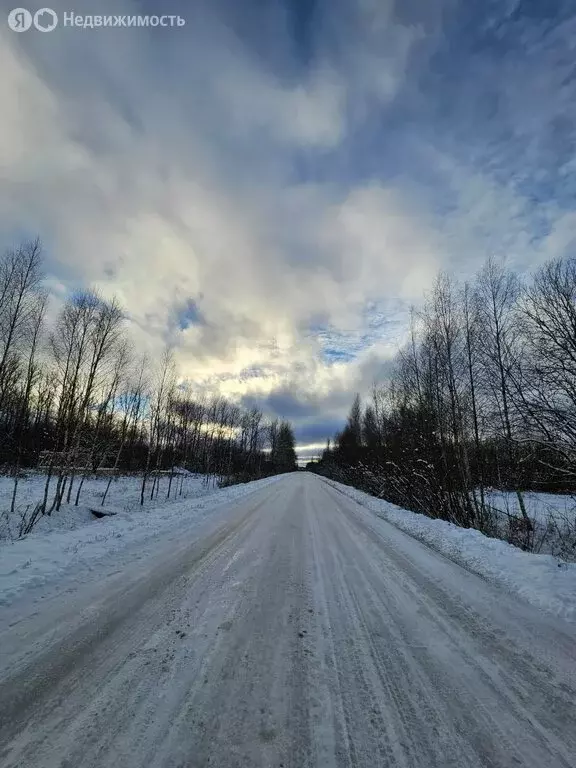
[0,0,576,457]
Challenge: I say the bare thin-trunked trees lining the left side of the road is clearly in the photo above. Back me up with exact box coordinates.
[0,240,296,516]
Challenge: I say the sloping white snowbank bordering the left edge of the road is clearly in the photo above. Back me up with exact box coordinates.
[0,477,277,606]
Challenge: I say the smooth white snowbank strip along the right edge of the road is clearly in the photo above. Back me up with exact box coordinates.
[326,480,576,622]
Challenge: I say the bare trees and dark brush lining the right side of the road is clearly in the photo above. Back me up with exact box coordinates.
[310,259,576,549]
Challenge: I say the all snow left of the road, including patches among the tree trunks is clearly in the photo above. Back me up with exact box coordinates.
[0,475,276,606]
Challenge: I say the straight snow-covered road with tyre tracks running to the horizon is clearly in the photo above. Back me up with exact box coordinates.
[0,473,576,768]
